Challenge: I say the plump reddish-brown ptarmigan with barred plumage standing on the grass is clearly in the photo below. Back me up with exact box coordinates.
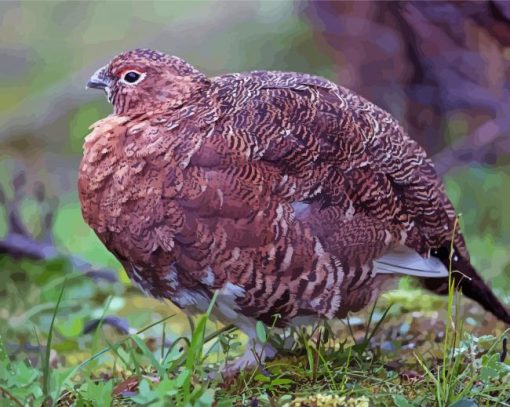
[79,49,510,372]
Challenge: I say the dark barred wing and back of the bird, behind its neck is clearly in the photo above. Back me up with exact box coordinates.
[205,72,464,278]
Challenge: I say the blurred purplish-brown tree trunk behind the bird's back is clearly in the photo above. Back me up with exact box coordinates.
[302,0,510,172]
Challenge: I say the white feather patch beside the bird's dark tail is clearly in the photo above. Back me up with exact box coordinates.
[374,246,448,278]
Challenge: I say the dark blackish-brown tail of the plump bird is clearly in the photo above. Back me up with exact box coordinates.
[421,247,510,324]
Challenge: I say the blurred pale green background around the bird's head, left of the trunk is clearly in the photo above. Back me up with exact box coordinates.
[0,1,333,265]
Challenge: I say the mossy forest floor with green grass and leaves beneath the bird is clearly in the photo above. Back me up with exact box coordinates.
[0,257,510,407]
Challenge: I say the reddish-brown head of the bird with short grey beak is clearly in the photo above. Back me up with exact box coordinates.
[87,49,209,115]
